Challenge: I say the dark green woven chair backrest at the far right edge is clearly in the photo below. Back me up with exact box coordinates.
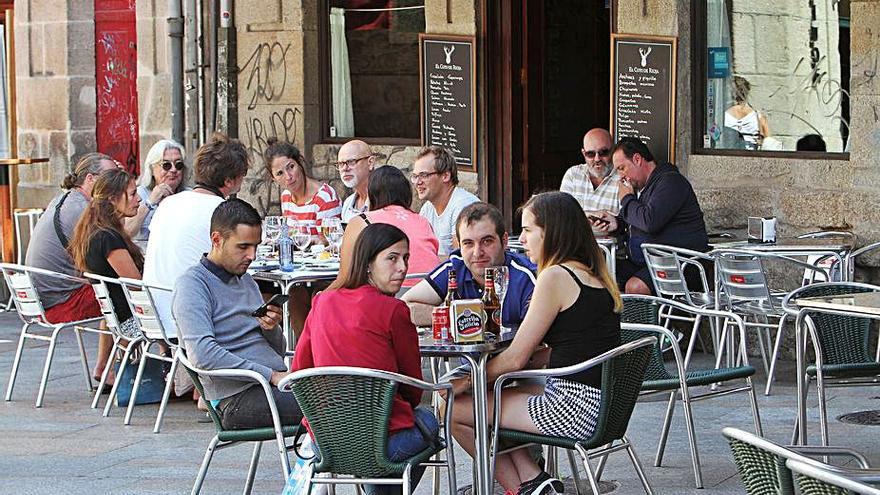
[783,282,880,365]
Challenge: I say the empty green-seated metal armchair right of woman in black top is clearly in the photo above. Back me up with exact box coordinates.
[621,295,763,488]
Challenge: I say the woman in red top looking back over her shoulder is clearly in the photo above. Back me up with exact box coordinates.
[292,223,439,494]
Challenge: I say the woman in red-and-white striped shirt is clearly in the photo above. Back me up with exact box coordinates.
[263,138,342,235]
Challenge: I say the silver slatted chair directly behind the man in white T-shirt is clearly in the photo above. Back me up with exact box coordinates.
[118,277,181,433]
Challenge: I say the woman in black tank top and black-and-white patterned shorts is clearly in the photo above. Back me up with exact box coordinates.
[452,192,623,494]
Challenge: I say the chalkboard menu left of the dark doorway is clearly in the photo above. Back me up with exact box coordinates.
[419,34,477,171]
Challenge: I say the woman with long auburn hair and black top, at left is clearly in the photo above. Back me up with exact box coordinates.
[68,169,144,385]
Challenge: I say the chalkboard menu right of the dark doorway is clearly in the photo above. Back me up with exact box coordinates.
[611,33,676,163]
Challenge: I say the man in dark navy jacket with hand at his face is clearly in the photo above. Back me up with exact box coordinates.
[594,138,709,294]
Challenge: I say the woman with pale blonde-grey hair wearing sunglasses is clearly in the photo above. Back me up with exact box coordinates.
[125,139,187,250]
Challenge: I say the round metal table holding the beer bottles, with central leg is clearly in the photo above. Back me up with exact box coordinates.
[419,332,510,495]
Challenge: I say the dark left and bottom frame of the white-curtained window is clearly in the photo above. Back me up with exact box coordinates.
[318,0,422,146]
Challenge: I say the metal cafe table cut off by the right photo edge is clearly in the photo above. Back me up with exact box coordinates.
[795,292,880,445]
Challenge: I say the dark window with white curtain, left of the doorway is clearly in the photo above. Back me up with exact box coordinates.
[322,0,425,141]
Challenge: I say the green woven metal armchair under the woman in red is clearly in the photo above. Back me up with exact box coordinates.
[278,366,455,495]
